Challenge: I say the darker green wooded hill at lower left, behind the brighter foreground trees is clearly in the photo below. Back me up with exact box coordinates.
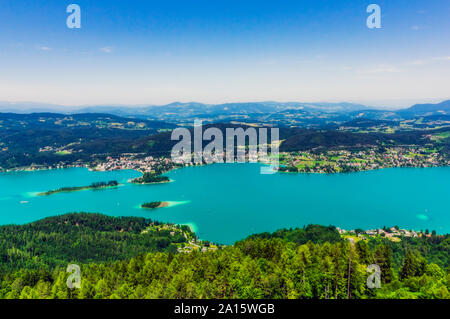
[0,213,191,272]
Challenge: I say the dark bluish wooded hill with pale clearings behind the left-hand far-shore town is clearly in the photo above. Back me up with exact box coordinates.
[0,113,175,169]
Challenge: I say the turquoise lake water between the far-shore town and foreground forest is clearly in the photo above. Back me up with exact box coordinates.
[0,164,450,244]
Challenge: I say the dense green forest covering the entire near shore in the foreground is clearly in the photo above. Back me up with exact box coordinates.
[0,214,450,299]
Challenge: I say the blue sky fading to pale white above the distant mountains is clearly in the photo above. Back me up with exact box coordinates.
[0,0,450,107]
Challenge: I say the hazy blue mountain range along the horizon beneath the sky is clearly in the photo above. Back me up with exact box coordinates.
[0,100,450,128]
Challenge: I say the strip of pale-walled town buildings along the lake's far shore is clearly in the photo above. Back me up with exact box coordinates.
[4,146,450,174]
